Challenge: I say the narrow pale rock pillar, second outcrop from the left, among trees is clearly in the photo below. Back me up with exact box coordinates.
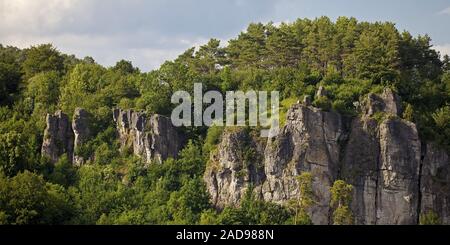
[72,108,91,166]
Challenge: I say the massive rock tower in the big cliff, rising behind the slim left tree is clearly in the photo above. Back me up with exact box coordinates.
[263,105,343,224]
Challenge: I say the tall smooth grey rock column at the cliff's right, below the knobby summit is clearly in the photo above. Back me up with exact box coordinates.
[377,119,421,225]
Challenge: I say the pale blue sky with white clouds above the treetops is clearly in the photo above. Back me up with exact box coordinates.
[0,0,450,71]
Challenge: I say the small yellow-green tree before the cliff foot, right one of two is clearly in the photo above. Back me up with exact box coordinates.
[330,180,354,225]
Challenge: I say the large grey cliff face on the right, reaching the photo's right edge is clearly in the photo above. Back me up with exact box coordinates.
[205,89,450,224]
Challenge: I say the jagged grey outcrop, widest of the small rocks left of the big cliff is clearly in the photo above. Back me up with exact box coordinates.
[113,109,184,163]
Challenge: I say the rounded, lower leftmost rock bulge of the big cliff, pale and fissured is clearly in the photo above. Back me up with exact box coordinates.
[204,130,265,208]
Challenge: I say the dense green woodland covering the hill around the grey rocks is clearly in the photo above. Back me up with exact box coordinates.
[0,17,450,224]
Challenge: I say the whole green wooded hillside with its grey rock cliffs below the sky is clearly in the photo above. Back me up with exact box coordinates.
[0,17,450,224]
